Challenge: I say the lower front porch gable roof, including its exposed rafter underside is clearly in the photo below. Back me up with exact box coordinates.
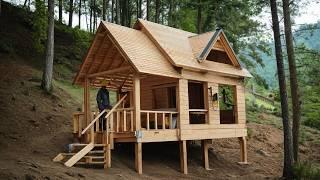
[74,22,181,84]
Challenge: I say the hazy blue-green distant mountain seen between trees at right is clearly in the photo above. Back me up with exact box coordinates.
[256,21,320,88]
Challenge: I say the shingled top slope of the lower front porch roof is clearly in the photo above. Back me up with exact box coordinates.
[102,22,180,77]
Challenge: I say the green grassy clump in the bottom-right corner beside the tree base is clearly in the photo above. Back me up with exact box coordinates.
[293,162,320,180]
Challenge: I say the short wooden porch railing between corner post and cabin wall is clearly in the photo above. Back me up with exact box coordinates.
[140,110,178,130]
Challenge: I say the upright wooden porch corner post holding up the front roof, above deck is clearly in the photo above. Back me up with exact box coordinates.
[133,75,141,131]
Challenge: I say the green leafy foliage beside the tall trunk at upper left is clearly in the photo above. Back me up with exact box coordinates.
[32,0,48,53]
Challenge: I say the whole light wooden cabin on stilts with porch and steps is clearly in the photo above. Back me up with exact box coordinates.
[54,19,251,174]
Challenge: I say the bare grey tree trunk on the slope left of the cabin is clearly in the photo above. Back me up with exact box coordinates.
[41,0,54,93]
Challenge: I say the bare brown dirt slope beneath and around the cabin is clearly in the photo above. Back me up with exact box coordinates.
[0,55,320,179]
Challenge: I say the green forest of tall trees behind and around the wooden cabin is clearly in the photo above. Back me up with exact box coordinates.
[0,0,320,179]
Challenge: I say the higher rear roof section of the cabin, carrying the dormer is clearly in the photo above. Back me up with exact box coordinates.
[134,19,251,77]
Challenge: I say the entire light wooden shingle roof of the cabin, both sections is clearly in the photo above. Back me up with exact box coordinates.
[74,19,251,84]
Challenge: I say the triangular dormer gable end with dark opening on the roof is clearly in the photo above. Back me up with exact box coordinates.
[197,29,241,68]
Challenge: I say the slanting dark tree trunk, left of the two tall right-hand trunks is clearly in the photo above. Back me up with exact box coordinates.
[270,0,293,179]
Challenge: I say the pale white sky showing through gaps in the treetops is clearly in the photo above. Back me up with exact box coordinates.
[8,0,320,30]
